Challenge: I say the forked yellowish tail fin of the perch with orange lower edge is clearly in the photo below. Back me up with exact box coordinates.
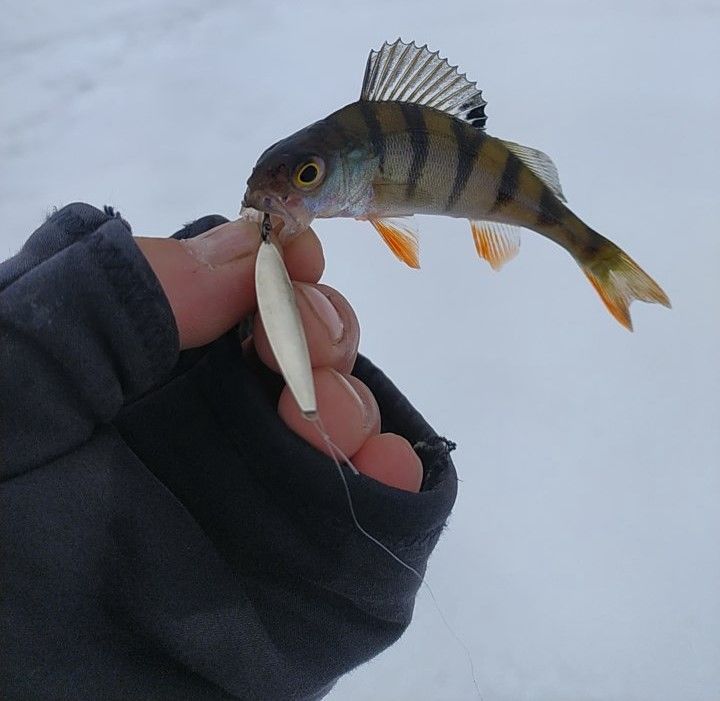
[576,232,670,331]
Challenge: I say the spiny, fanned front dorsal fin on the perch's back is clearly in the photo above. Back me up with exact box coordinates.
[360,39,487,129]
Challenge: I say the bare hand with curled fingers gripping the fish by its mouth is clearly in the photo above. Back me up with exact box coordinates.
[135,221,422,492]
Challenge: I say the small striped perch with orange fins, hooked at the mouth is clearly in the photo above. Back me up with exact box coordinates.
[243,39,671,331]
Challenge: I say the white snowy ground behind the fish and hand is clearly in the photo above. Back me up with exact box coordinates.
[0,0,720,701]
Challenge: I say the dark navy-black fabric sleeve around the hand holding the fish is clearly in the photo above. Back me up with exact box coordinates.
[0,204,457,700]
